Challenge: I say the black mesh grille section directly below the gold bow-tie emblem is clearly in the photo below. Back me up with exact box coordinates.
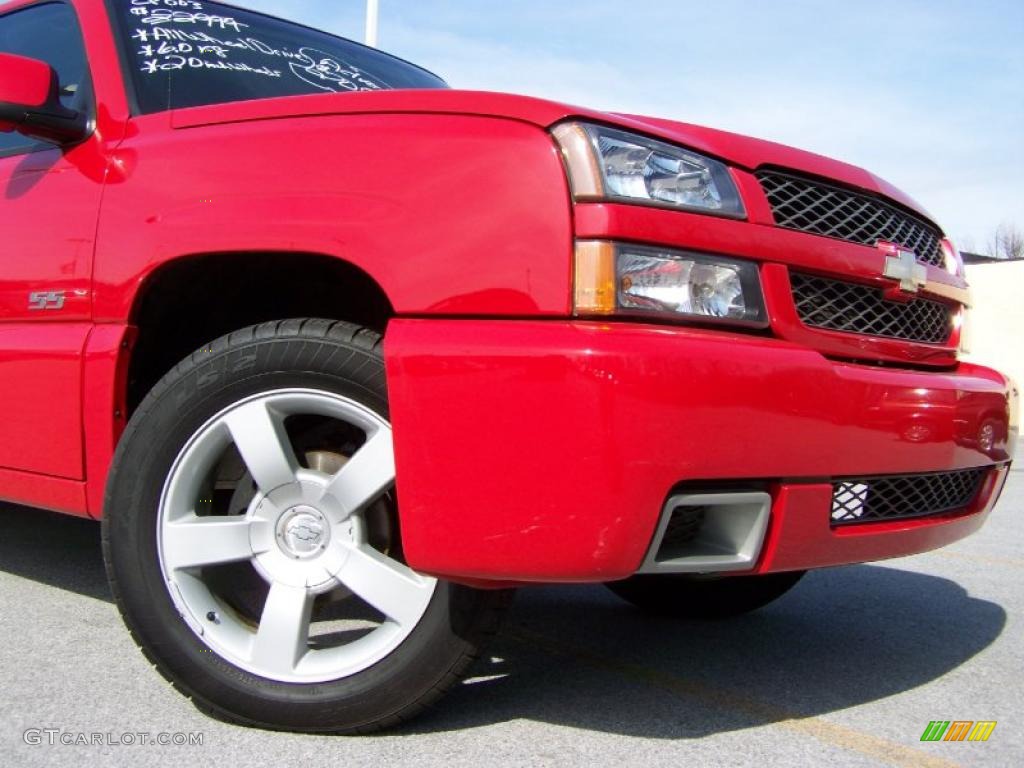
[790,272,953,344]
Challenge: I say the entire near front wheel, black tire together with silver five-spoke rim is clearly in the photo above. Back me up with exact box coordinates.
[103,318,511,733]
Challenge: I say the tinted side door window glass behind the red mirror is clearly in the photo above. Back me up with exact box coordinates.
[0,3,89,155]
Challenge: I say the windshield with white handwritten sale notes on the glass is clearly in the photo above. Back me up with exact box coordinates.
[111,0,446,114]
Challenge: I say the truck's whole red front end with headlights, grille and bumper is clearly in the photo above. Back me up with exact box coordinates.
[386,116,1017,584]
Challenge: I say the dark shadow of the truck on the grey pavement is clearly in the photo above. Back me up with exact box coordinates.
[0,505,1007,738]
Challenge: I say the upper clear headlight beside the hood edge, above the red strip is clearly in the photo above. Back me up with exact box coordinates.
[553,123,745,218]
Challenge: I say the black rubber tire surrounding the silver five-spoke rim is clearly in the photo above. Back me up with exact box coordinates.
[102,319,512,733]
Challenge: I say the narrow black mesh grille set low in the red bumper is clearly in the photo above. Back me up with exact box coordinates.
[831,467,988,525]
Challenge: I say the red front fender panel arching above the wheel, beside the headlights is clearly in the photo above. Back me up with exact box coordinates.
[95,114,572,322]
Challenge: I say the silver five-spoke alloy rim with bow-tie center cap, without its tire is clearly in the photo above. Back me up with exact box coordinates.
[158,389,436,683]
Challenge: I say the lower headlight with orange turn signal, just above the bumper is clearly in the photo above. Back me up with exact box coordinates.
[574,241,768,328]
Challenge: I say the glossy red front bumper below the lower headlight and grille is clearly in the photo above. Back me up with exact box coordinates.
[385,319,1016,583]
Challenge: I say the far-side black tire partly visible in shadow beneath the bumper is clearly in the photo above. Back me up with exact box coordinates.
[605,570,806,620]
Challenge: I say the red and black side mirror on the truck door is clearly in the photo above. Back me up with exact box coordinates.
[0,53,89,144]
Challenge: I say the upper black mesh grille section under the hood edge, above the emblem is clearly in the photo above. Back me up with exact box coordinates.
[757,171,943,266]
